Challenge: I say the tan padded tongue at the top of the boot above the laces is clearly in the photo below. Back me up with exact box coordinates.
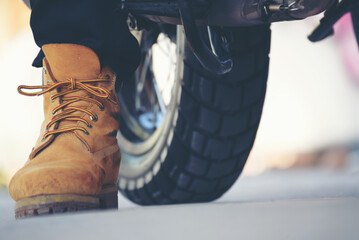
[42,44,101,81]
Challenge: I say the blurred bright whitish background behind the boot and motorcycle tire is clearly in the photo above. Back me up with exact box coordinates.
[0,0,359,187]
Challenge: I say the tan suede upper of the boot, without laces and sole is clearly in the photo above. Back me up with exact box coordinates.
[9,44,121,201]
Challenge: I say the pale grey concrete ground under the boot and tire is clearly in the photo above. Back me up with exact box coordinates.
[0,171,359,240]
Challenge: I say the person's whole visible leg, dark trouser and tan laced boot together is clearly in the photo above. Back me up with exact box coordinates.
[9,0,139,217]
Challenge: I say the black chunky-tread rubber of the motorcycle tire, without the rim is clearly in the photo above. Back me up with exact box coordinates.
[120,25,271,205]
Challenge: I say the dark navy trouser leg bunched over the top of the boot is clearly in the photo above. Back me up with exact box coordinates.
[30,0,140,80]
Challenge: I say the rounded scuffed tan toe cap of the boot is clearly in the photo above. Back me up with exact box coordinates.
[9,160,104,201]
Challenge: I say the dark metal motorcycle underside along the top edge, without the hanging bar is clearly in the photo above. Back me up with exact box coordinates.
[117,0,336,27]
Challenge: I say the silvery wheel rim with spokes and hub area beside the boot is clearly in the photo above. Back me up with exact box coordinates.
[118,26,185,180]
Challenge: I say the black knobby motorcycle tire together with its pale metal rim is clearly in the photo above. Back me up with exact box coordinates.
[118,25,271,205]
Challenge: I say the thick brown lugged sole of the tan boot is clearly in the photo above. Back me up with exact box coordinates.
[15,185,118,219]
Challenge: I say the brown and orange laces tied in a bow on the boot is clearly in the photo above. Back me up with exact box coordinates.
[17,78,117,140]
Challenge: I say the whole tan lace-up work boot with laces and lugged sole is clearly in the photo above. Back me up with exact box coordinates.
[9,44,121,217]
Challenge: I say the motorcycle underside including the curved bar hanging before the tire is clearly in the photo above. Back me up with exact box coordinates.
[120,0,335,75]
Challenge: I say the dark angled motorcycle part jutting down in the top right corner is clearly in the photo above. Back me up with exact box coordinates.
[308,0,359,42]
